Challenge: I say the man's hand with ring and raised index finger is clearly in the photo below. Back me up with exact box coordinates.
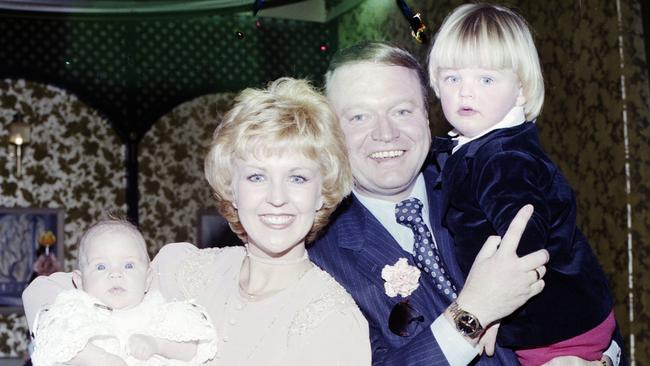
[457,205,549,327]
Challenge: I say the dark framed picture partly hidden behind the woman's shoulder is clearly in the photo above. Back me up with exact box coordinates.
[196,208,243,248]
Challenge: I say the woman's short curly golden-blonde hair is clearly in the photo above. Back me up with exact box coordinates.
[204,78,352,241]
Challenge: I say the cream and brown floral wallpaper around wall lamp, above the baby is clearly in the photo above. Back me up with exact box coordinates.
[0,79,126,357]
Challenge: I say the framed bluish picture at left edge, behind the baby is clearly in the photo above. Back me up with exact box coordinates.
[0,207,63,314]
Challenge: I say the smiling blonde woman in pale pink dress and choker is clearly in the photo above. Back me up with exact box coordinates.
[24,78,371,365]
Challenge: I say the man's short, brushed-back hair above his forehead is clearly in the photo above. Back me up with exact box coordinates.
[325,42,429,108]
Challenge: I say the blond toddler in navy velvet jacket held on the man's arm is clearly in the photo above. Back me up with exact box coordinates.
[429,4,617,365]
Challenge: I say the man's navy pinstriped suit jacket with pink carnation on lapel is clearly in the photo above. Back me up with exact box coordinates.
[309,165,518,366]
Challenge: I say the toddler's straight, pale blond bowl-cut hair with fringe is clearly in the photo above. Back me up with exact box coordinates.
[429,4,544,121]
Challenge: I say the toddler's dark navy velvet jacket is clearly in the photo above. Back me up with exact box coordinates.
[438,122,612,349]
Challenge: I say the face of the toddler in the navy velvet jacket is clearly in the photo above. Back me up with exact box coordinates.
[436,67,526,137]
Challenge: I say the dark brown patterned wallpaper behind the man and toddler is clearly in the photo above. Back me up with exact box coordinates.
[339,0,650,365]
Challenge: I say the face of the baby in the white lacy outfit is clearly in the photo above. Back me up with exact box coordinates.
[81,230,151,309]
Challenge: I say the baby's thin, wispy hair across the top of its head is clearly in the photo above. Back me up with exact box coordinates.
[77,215,149,269]
